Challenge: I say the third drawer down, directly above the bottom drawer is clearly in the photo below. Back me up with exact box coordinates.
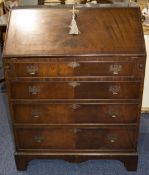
[12,103,138,124]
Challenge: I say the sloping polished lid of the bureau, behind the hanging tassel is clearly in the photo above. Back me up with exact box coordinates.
[3,7,145,57]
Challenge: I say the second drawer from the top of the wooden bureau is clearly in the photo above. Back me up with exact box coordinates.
[10,81,140,99]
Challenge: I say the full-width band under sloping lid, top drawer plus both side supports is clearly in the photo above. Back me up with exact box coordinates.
[4,56,145,80]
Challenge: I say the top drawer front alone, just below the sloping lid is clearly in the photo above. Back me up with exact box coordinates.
[11,61,136,77]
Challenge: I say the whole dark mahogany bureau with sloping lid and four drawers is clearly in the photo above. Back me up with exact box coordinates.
[3,7,146,170]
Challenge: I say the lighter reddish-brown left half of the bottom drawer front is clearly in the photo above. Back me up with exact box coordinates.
[16,128,75,149]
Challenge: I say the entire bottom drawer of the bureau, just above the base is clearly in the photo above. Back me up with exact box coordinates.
[16,127,136,150]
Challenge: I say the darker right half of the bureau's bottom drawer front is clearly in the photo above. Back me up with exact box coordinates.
[76,128,136,150]
